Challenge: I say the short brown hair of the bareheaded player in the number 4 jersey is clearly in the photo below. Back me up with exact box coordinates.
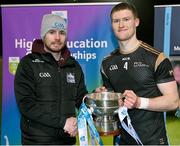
[111,2,138,18]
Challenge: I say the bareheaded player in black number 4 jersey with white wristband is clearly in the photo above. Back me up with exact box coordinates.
[96,3,178,145]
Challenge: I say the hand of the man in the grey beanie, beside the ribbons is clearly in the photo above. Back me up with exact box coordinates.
[64,117,77,137]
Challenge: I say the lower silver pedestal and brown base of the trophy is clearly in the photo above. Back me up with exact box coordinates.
[94,115,120,136]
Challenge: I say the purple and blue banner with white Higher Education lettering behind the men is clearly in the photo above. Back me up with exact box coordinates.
[1,3,117,145]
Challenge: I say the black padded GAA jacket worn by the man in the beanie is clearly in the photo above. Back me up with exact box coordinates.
[14,50,87,140]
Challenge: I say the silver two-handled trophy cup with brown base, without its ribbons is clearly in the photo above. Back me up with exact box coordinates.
[85,92,123,135]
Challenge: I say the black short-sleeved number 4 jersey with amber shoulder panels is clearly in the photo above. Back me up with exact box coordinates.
[101,42,174,145]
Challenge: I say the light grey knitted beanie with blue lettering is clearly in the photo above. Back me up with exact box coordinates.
[41,14,67,39]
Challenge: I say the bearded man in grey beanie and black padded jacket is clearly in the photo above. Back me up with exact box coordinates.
[14,14,87,145]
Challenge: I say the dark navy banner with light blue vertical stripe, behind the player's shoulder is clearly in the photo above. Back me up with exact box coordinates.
[154,5,180,57]
